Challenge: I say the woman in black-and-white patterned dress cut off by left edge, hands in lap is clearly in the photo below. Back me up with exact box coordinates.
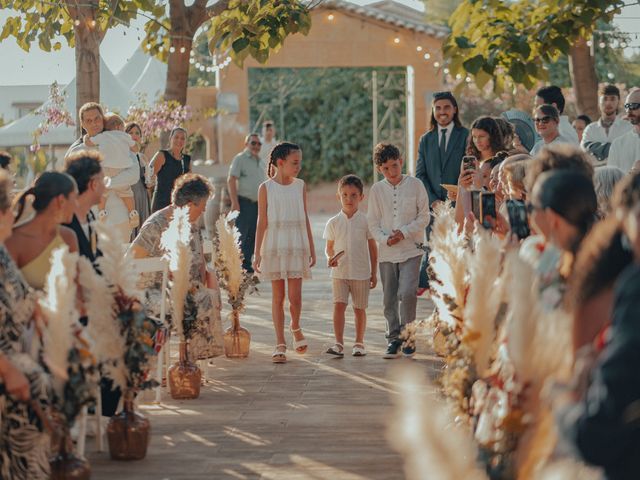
[0,172,50,480]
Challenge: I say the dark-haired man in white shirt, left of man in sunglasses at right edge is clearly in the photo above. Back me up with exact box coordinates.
[581,85,633,165]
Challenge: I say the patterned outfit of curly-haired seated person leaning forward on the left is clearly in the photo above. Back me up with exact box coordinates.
[132,207,223,360]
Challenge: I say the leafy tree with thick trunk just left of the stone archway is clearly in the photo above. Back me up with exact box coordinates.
[144,0,313,104]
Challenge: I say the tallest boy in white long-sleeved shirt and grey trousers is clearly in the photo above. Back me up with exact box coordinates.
[367,143,429,358]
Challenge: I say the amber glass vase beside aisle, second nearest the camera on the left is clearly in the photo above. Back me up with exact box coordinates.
[107,390,151,460]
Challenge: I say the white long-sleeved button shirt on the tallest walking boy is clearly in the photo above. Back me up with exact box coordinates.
[367,175,430,263]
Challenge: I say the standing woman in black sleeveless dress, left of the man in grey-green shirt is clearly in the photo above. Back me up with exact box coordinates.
[149,127,191,213]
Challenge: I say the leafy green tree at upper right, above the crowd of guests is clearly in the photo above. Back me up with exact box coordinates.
[444,0,624,116]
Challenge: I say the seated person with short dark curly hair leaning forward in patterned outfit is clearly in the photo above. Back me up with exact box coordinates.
[131,174,223,360]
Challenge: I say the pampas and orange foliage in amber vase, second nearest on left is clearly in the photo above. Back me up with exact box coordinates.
[79,225,162,460]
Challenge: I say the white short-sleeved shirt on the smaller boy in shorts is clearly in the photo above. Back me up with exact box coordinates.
[322,210,373,280]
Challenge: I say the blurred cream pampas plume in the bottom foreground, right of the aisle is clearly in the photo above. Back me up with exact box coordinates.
[388,366,487,480]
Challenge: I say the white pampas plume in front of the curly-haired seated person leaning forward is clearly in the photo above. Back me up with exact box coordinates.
[160,207,193,342]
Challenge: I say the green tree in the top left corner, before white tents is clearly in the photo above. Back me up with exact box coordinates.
[0,0,164,128]
